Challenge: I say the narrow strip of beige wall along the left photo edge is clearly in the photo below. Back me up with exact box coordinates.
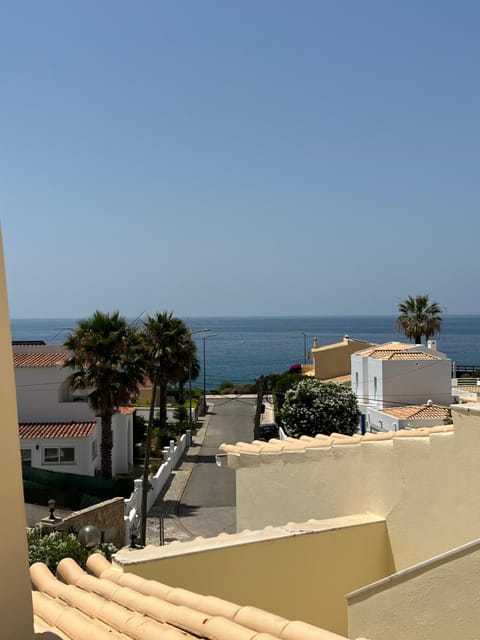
[0,228,34,640]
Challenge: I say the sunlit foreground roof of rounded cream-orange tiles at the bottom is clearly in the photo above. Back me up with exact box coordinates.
[30,554,343,640]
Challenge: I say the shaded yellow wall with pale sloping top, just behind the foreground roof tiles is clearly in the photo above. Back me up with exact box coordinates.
[115,516,395,634]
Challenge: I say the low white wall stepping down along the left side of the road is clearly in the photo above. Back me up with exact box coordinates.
[124,431,192,544]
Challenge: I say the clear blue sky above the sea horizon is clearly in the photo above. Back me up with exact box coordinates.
[0,0,480,318]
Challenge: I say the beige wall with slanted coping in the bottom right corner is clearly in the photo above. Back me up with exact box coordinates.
[348,541,480,640]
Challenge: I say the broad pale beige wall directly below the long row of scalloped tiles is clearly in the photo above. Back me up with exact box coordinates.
[235,406,480,568]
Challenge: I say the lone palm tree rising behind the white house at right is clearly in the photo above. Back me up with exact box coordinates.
[395,295,443,344]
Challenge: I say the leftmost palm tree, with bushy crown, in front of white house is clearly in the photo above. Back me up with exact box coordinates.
[64,311,145,478]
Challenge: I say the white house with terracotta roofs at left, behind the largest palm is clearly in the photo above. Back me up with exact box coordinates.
[13,343,134,476]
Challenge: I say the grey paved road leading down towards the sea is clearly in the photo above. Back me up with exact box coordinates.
[178,397,255,537]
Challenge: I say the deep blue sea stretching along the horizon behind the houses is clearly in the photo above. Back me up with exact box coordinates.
[11,315,480,390]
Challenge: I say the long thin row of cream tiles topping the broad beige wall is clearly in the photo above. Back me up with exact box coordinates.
[220,425,453,467]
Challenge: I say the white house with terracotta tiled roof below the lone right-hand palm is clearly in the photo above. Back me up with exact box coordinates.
[351,340,452,431]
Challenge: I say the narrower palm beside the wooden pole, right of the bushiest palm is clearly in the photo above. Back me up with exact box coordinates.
[144,311,196,440]
